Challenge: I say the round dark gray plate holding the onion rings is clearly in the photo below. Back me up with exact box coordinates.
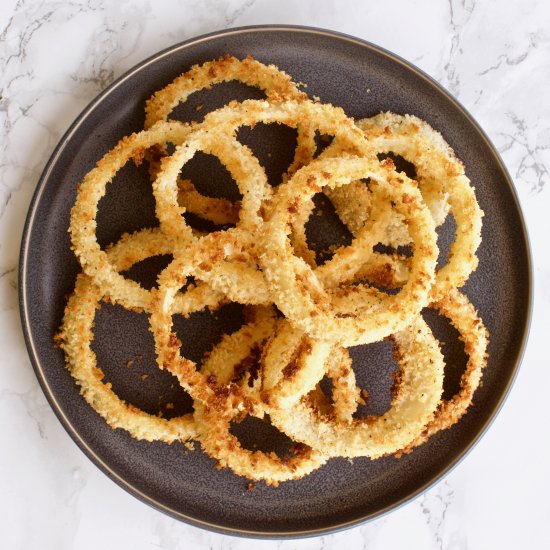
[20,27,531,537]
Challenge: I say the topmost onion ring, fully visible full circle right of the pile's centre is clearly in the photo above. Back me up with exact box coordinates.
[260,156,437,346]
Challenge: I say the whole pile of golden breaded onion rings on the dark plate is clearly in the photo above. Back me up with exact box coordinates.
[56,56,488,485]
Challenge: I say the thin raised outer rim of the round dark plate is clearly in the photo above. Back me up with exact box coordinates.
[18,24,533,539]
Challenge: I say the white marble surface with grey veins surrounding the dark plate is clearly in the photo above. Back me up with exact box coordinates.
[0,0,550,550]
